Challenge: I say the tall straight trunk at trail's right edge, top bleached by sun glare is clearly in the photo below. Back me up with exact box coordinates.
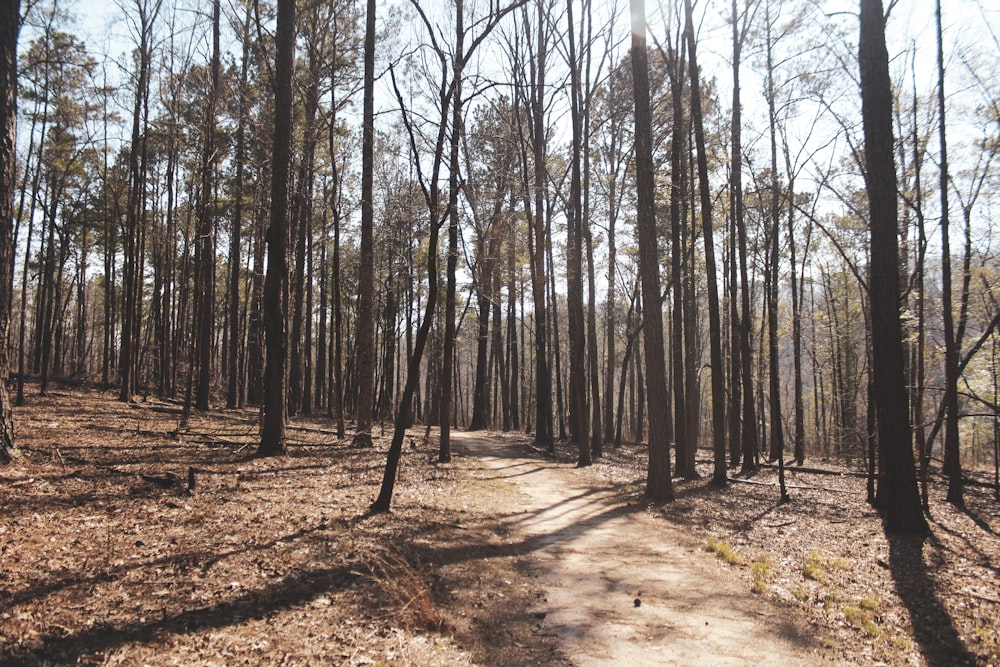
[630,0,674,502]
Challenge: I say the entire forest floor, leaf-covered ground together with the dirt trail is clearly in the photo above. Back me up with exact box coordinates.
[0,388,1000,666]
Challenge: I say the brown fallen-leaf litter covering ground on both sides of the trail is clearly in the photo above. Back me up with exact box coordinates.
[0,389,1000,666]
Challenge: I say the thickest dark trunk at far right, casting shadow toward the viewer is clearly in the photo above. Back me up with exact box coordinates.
[858,0,927,534]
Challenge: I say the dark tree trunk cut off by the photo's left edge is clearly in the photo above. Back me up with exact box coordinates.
[0,0,21,463]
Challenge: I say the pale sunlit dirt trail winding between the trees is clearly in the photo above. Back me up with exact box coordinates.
[452,433,844,666]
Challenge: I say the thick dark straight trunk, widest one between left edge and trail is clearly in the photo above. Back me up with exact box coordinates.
[257,0,294,456]
